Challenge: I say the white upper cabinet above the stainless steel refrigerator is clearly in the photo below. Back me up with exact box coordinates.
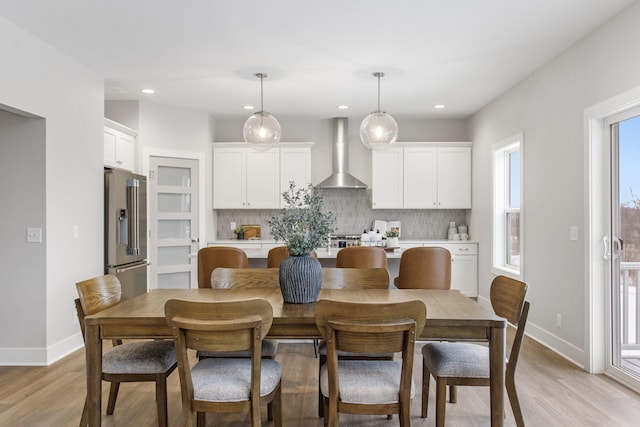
[104,119,137,171]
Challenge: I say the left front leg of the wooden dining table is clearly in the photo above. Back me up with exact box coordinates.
[85,325,102,427]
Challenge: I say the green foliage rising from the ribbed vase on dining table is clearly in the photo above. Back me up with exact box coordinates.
[267,181,335,256]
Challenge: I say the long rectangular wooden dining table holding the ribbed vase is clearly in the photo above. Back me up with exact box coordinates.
[85,269,507,426]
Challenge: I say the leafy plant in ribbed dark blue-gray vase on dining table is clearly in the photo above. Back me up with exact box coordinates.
[267,181,335,304]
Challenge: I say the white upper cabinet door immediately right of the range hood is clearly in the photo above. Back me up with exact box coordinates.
[371,148,403,209]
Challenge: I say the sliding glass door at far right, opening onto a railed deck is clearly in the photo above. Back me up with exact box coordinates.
[607,110,640,389]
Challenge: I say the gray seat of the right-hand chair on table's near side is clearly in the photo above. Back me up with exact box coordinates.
[320,360,415,404]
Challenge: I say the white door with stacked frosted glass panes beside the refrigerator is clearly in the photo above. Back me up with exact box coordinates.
[148,156,200,289]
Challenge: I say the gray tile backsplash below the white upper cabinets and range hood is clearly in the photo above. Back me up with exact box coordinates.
[216,189,473,240]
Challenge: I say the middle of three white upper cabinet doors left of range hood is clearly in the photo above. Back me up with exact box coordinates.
[246,148,280,209]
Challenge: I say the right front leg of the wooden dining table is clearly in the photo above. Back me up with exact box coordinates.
[489,327,506,427]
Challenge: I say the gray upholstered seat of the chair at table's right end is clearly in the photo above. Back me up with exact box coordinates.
[422,342,489,378]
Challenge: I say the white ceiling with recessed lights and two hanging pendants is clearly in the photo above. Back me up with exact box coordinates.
[0,0,633,119]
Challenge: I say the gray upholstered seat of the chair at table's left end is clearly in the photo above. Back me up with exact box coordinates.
[102,340,176,374]
